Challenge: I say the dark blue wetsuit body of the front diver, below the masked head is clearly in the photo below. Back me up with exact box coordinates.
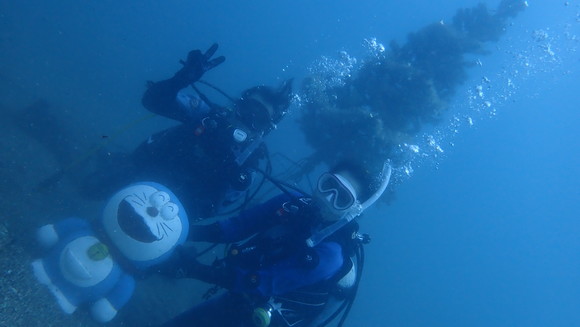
[164,195,350,327]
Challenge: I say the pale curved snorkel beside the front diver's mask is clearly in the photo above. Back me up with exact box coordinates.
[306,162,392,247]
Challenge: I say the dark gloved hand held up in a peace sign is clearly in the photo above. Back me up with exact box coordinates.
[176,43,226,84]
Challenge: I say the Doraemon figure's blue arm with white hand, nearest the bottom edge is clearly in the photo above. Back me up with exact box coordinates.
[91,273,135,323]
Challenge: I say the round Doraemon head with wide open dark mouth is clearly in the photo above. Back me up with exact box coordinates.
[103,182,188,262]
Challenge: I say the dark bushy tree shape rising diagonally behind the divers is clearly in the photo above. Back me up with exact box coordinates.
[299,0,526,179]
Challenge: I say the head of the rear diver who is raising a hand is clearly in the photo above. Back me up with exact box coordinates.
[235,79,292,133]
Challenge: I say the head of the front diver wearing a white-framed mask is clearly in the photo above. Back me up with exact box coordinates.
[314,162,390,221]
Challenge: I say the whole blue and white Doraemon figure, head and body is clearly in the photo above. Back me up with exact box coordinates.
[32,182,189,322]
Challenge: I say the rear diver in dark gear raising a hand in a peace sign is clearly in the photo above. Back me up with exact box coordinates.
[85,44,292,219]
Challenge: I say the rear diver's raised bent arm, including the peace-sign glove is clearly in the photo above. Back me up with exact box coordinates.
[142,44,225,122]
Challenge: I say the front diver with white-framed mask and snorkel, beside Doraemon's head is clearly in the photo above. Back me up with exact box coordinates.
[162,161,391,327]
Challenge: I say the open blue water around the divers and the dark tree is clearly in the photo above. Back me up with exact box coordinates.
[0,0,580,327]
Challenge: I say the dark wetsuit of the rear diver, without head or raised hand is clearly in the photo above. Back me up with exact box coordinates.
[85,74,264,220]
